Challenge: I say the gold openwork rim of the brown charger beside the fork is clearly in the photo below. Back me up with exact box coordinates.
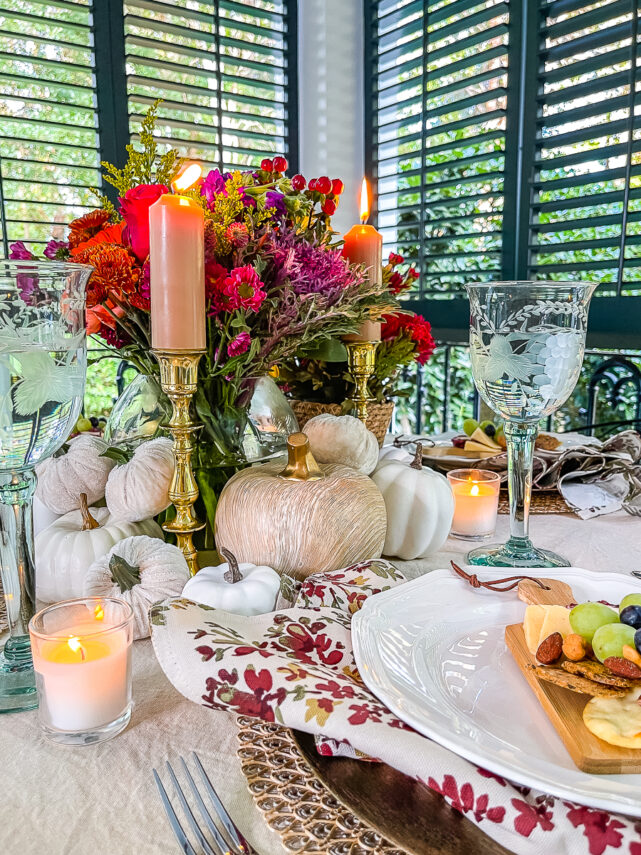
[238,716,406,855]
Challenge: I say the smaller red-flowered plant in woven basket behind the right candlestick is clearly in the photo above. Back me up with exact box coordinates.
[280,253,436,410]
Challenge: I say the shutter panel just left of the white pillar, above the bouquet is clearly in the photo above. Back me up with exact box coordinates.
[125,0,295,168]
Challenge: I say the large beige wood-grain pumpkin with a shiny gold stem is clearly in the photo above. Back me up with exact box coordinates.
[215,433,386,579]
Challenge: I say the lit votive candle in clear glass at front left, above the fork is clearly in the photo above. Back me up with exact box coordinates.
[29,597,134,745]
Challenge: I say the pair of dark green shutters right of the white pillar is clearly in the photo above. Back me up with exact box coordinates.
[366,0,641,346]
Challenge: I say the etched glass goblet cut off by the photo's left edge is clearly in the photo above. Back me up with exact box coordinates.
[0,260,92,713]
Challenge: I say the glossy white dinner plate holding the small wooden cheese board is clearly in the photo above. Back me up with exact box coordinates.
[352,567,641,817]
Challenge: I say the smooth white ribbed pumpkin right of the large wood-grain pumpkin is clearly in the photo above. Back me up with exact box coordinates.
[372,443,454,561]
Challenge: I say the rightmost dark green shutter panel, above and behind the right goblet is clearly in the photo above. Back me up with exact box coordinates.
[530,0,641,295]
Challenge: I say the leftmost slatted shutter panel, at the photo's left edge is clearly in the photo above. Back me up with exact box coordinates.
[0,0,100,255]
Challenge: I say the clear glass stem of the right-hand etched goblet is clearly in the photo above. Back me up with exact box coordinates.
[504,421,537,553]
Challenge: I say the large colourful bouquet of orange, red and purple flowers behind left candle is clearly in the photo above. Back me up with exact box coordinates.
[11,102,395,536]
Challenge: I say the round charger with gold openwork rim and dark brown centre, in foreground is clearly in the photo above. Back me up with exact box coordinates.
[238,716,509,855]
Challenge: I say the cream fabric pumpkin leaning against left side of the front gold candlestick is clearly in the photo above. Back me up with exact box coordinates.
[105,437,175,522]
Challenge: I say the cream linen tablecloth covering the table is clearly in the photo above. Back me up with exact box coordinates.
[0,513,641,855]
